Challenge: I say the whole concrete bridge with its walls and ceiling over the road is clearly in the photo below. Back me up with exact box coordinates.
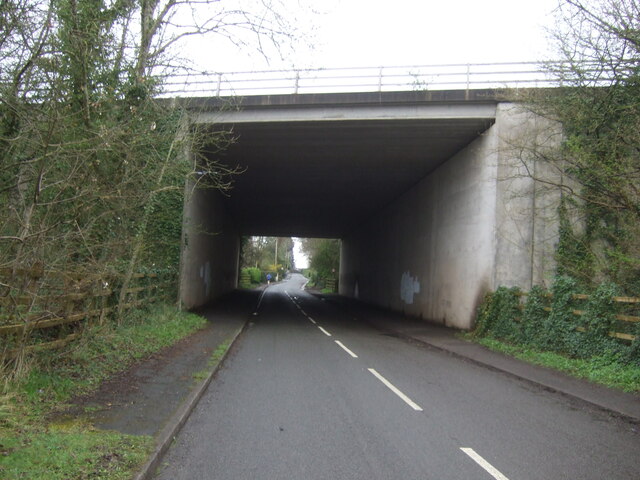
[181,90,559,328]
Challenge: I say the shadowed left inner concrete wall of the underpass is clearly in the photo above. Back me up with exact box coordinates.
[180,185,240,309]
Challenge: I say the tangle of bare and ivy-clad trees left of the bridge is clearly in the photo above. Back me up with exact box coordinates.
[0,0,310,368]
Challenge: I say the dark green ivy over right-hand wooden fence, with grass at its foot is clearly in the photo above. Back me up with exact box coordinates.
[469,276,640,390]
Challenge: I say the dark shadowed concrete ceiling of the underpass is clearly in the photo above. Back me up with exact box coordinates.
[198,93,493,238]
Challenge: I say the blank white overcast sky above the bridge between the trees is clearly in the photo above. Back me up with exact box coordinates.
[189,0,558,72]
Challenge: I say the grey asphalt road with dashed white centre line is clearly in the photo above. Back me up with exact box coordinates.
[156,275,640,480]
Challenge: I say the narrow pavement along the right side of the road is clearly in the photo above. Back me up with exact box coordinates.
[322,295,640,422]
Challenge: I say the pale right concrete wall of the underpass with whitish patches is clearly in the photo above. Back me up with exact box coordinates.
[340,103,559,329]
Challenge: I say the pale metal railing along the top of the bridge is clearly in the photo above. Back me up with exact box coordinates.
[163,62,558,97]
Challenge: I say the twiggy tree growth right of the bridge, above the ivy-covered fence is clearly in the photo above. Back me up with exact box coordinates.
[530,0,640,296]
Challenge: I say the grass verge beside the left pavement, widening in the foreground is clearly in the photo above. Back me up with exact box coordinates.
[0,305,206,480]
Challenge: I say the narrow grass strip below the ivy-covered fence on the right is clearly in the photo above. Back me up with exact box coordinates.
[463,334,640,392]
